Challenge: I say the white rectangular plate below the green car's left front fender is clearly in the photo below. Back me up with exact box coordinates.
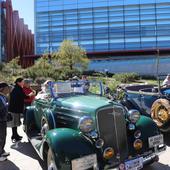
[71,154,97,170]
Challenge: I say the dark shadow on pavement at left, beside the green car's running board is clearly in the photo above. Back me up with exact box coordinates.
[9,141,45,170]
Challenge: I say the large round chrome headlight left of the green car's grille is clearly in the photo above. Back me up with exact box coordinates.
[79,116,94,133]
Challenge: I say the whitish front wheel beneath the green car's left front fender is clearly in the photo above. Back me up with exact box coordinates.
[47,148,58,170]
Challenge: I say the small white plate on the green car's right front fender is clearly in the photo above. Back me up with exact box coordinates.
[148,135,164,148]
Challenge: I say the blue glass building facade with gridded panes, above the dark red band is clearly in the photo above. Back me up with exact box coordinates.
[35,0,170,54]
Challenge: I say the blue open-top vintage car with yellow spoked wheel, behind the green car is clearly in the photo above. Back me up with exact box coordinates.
[120,84,170,132]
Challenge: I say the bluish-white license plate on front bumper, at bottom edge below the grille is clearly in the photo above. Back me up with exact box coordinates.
[125,157,143,170]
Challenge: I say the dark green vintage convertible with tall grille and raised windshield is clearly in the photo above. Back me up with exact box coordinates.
[25,81,165,170]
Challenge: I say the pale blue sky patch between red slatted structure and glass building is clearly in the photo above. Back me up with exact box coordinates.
[12,0,34,32]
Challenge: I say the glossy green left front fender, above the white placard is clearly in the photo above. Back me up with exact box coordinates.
[43,128,95,169]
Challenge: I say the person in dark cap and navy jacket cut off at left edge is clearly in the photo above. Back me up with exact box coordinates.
[0,82,10,162]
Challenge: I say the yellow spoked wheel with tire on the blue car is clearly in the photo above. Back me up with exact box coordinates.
[151,99,170,129]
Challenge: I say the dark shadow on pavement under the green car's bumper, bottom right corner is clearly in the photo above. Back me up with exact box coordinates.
[143,162,170,170]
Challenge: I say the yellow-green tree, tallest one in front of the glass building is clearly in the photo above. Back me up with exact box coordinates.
[56,40,89,71]
